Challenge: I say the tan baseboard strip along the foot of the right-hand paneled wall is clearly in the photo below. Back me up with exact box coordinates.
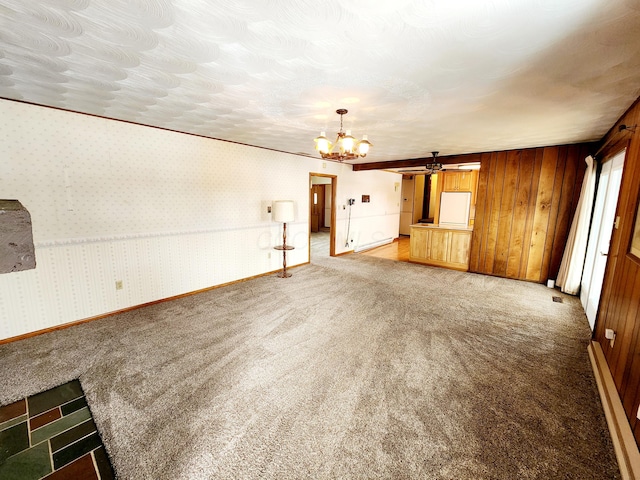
[587,341,640,480]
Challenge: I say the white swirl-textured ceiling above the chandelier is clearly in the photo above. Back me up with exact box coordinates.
[0,0,640,163]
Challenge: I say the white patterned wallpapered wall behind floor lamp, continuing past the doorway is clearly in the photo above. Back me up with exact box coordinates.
[0,100,400,339]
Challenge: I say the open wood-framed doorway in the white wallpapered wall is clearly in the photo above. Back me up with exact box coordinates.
[309,173,337,261]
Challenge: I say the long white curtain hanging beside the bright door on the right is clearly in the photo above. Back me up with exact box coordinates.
[556,155,596,295]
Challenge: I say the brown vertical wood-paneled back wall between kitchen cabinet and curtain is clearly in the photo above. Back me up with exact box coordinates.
[469,144,595,283]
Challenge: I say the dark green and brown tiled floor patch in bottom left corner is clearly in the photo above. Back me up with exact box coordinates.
[0,380,115,480]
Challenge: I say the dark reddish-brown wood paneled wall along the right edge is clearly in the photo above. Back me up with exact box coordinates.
[594,99,640,445]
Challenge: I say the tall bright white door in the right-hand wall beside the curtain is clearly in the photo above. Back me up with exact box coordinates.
[580,150,625,330]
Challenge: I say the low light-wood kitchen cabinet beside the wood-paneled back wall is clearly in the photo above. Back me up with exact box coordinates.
[409,225,472,272]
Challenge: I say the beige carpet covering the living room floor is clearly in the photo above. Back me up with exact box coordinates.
[0,249,619,480]
